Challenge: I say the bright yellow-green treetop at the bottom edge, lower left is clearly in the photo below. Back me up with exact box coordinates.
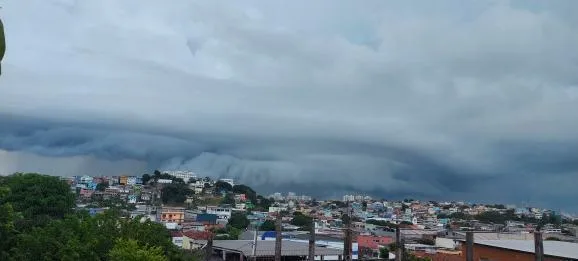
[108,239,168,261]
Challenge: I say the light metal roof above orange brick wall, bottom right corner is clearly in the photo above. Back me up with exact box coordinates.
[475,240,578,259]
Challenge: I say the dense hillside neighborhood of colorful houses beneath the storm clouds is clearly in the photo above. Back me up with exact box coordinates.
[57,171,578,260]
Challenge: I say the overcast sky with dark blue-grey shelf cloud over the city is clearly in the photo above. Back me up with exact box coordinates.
[0,0,578,211]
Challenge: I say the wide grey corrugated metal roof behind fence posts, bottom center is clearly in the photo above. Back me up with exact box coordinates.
[213,240,343,256]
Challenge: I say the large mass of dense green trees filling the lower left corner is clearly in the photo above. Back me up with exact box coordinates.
[0,174,194,261]
